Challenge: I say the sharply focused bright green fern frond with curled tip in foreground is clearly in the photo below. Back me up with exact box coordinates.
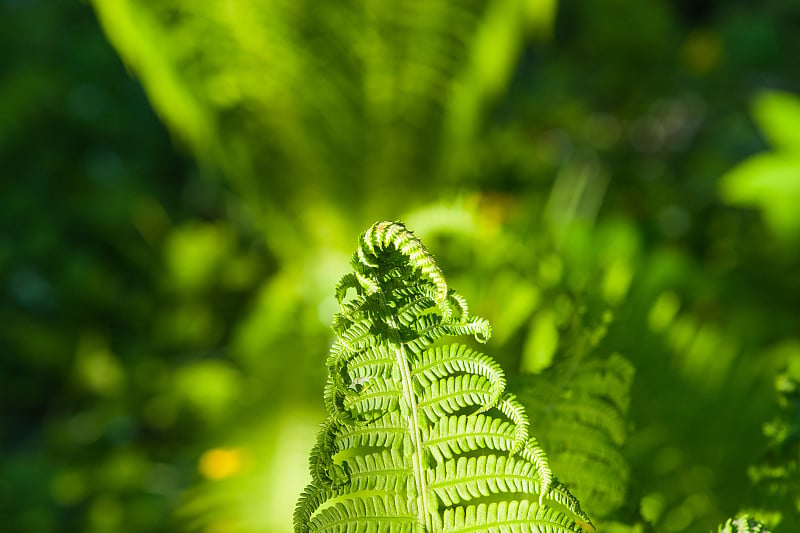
[294,222,593,533]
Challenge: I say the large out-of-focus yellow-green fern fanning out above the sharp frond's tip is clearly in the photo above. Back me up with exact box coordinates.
[93,0,546,237]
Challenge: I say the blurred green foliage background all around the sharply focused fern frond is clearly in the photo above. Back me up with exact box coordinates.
[0,0,800,533]
